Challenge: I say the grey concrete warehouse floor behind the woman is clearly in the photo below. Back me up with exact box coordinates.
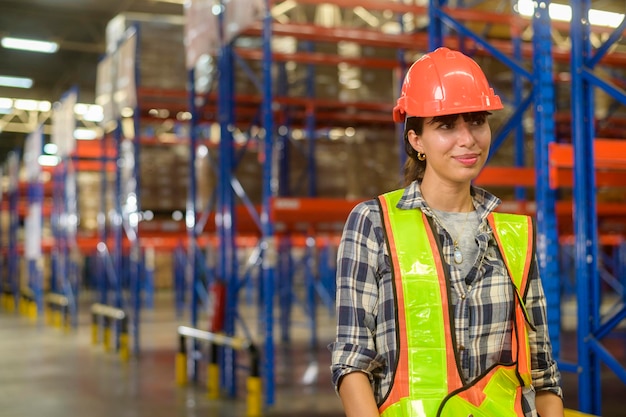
[0,294,626,417]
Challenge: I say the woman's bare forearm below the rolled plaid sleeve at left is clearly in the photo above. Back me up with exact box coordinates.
[339,372,380,417]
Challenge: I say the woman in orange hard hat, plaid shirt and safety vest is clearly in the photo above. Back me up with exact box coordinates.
[330,48,563,417]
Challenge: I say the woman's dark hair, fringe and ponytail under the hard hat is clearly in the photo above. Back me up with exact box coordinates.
[404,111,491,186]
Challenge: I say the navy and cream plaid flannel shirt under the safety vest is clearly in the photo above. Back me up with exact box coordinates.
[329,182,563,417]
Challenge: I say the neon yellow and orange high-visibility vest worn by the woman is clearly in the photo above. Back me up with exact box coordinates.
[379,190,534,417]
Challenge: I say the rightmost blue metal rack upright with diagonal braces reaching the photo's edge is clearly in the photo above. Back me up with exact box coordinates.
[570,0,626,415]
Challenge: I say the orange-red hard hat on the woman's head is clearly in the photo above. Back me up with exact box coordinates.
[393,48,502,122]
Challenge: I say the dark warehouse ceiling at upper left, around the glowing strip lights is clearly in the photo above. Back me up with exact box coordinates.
[0,0,183,162]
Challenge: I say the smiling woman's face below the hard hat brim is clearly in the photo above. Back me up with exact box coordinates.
[408,113,491,184]
